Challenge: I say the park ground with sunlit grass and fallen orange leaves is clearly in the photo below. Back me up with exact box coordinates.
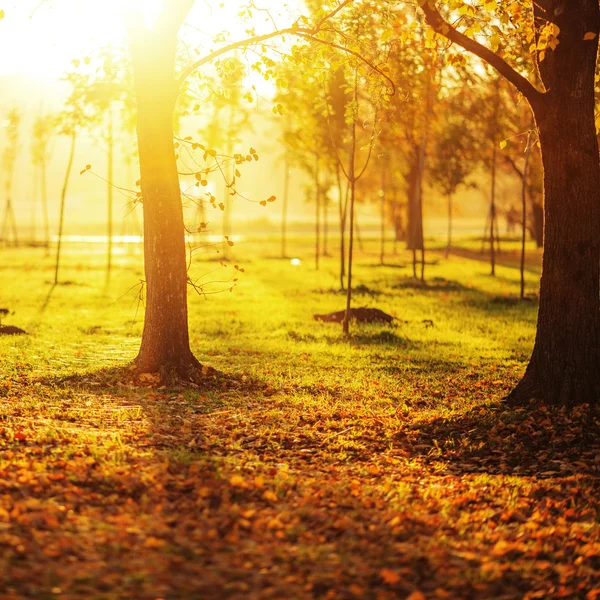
[0,237,600,600]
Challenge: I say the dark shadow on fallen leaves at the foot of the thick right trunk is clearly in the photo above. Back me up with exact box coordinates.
[394,403,600,479]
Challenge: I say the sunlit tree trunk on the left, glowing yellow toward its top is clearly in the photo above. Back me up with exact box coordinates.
[132,11,199,377]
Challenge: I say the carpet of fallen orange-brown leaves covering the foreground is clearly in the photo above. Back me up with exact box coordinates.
[7,368,600,600]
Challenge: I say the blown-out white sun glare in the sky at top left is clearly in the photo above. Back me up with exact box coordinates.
[0,0,301,78]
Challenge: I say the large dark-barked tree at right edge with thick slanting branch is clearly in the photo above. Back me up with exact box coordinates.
[419,0,600,404]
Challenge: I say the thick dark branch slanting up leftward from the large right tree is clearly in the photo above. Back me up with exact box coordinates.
[418,0,544,106]
